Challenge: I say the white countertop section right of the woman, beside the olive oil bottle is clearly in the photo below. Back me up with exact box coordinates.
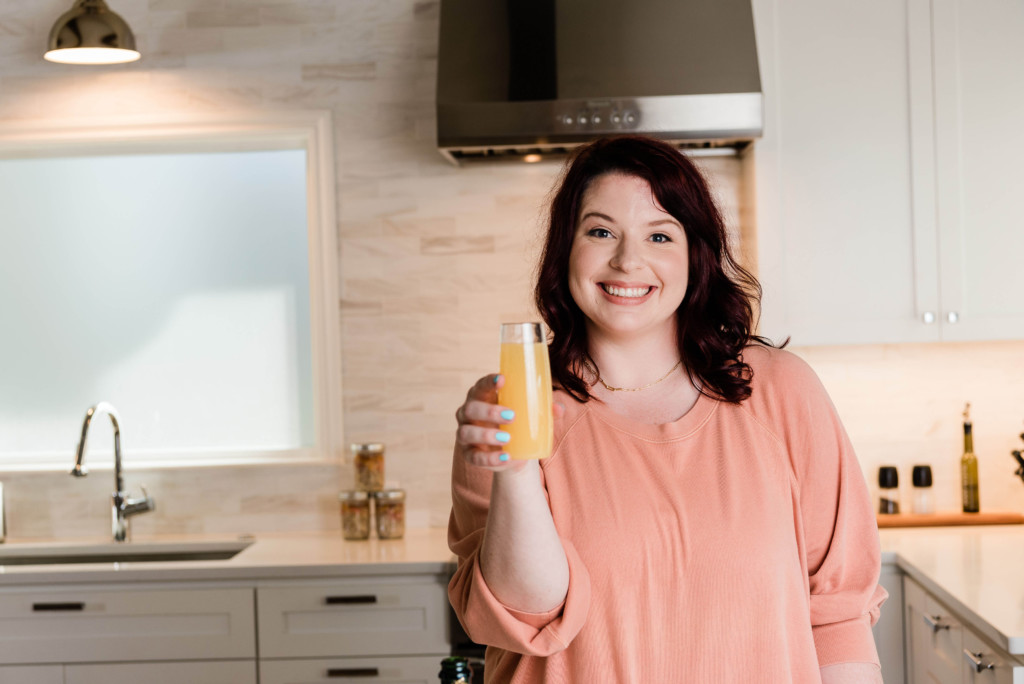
[879,525,1024,654]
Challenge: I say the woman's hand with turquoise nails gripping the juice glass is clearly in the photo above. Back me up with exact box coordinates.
[455,375,526,472]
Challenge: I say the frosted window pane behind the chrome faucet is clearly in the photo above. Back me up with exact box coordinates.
[0,149,314,464]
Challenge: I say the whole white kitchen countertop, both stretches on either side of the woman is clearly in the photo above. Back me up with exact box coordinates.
[0,525,1024,654]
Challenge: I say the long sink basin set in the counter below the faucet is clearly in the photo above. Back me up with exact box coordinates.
[0,538,256,565]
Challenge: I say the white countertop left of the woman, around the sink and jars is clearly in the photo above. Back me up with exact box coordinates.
[0,527,455,586]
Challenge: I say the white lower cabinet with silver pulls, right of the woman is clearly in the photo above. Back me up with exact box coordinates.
[903,576,1024,684]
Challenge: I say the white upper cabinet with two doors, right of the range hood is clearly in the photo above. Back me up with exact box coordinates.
[753,0,1024,344]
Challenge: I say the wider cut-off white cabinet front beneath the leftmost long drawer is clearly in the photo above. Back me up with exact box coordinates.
[63,660,256,684]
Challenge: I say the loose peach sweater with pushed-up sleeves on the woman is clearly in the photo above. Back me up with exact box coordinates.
[449,346,886,684]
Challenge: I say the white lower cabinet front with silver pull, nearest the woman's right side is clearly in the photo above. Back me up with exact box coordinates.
[903,578,964,684]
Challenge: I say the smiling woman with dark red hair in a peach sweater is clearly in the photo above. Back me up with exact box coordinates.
[449,136,886,684]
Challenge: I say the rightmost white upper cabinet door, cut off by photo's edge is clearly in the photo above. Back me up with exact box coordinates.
[933,0,1024,340]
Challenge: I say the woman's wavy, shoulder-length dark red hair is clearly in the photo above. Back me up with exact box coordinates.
[535,135,771,403]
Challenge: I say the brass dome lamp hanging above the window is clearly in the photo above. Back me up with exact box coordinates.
[43,0,141,65]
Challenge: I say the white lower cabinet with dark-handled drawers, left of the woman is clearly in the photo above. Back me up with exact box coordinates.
[0,573,452,684]
